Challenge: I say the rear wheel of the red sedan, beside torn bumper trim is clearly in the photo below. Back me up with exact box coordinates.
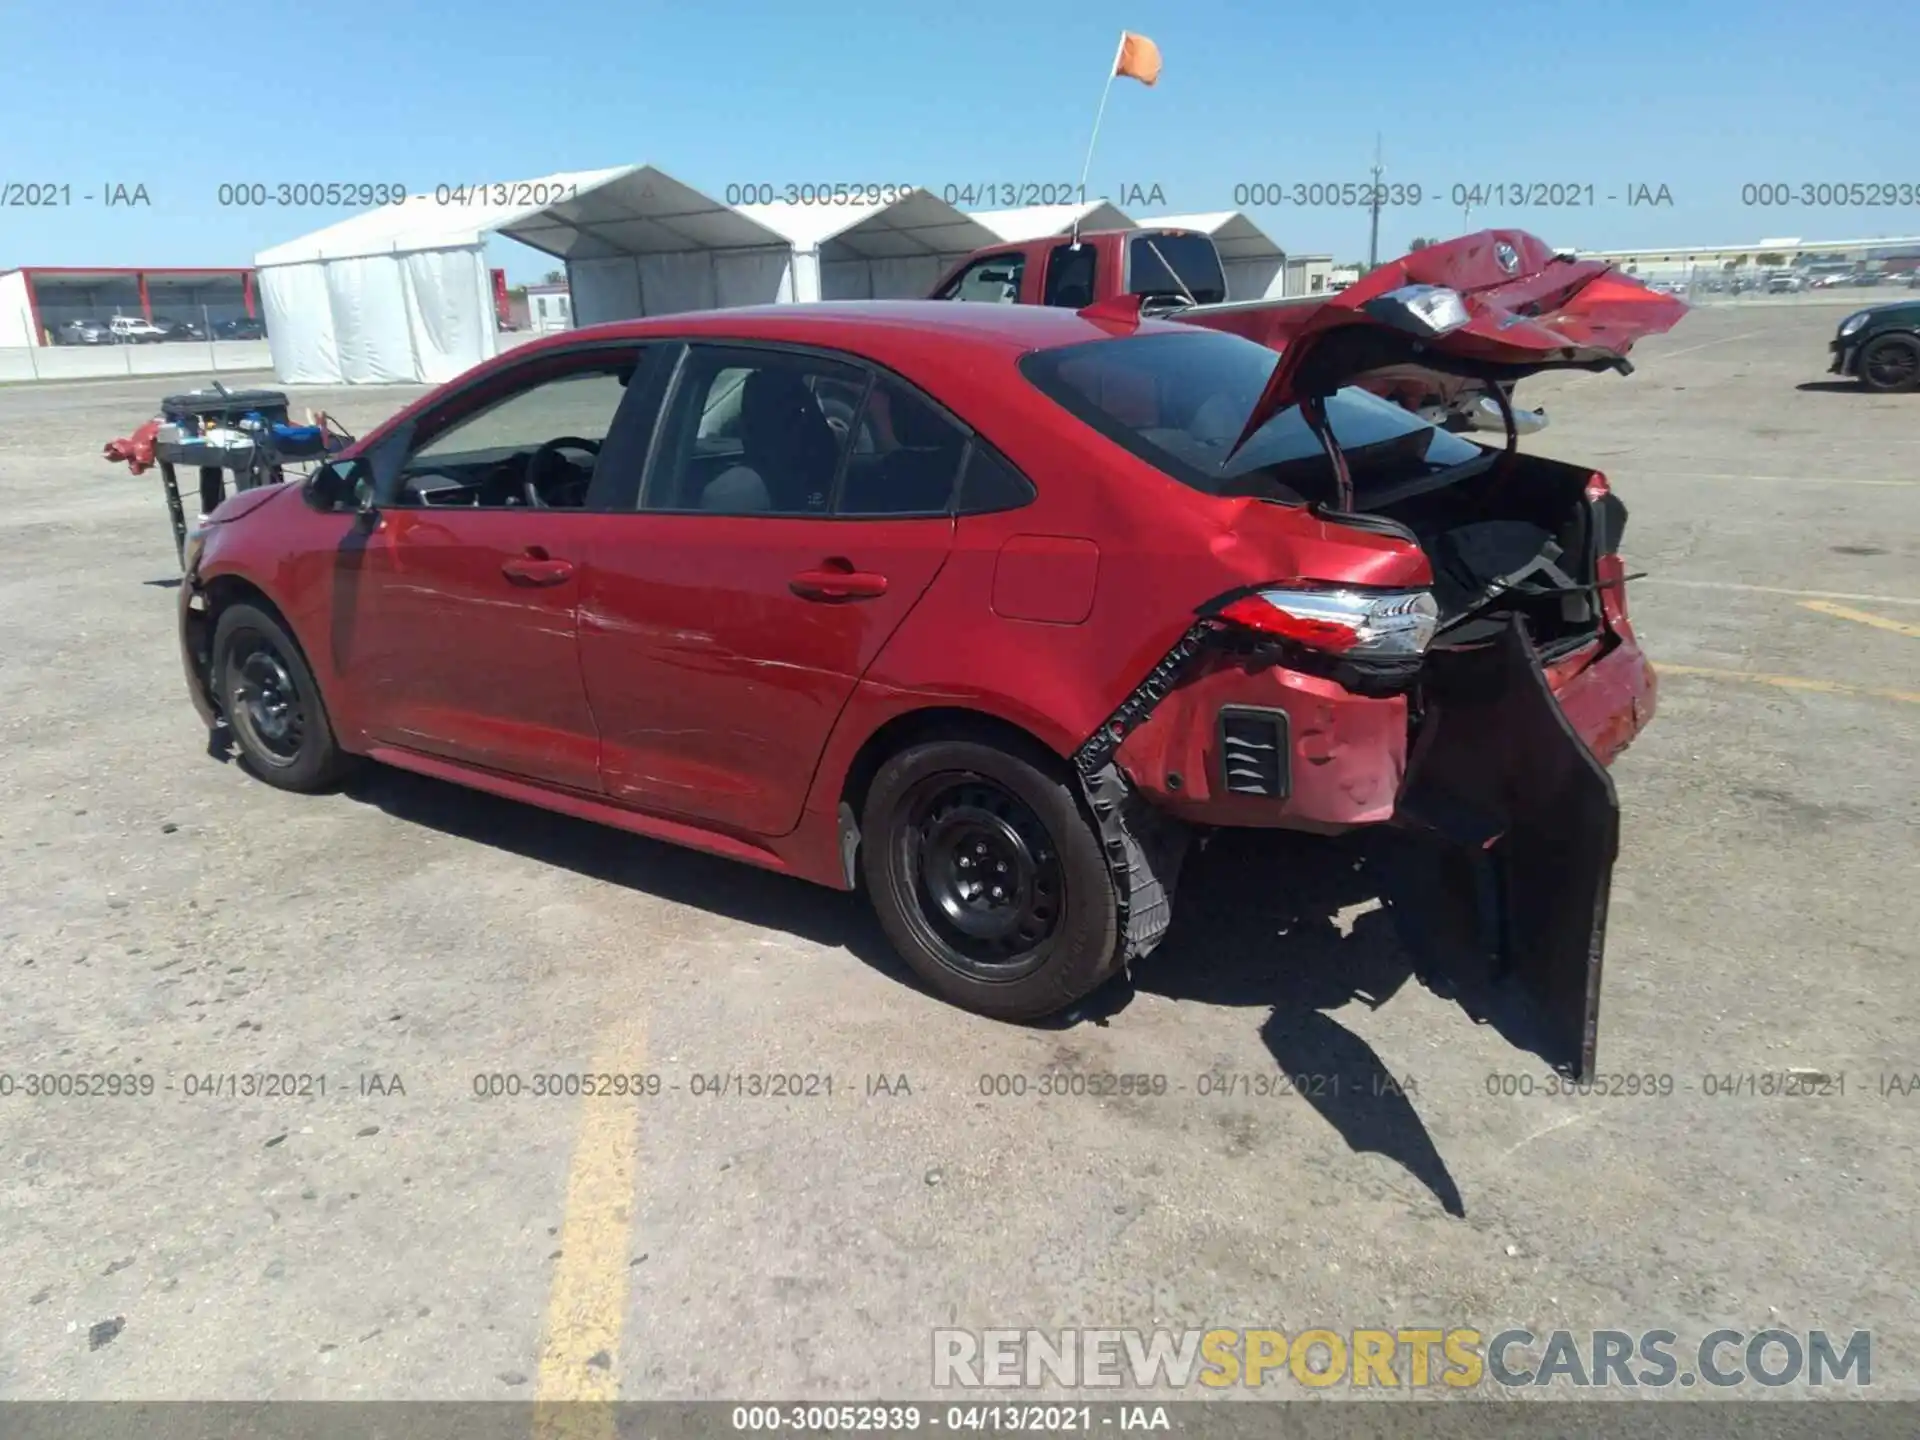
[860,739,1121,1020]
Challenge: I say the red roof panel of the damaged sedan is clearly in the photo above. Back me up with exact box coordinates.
[536,300,1194,355]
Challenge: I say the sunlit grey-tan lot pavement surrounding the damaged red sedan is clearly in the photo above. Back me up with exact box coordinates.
[0,305,1920,1400]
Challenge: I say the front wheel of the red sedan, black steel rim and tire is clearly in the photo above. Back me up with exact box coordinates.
[213,603,351,791]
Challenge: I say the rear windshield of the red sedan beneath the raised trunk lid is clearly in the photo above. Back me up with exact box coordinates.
[1020,330,1492,509]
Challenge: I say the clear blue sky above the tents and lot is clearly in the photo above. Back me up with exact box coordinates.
[0,0,1920,280]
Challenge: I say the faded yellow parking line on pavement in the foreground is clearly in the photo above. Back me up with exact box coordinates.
[534,1014,647,1440]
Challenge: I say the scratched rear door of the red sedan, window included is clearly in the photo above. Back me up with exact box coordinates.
[580,344,968,835]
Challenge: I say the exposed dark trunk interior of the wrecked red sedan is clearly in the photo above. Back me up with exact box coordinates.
[1373,455,1624,659]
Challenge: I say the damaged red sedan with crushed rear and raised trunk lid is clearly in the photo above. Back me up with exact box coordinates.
[180,231,1672,1073]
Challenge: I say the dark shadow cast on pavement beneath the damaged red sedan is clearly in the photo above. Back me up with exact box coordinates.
[344,764,1530,1215]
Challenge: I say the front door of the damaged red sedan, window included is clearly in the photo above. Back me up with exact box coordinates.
[336,348,647,791]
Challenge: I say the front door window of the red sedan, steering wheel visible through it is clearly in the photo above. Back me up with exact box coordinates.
[394,353,634,509]
